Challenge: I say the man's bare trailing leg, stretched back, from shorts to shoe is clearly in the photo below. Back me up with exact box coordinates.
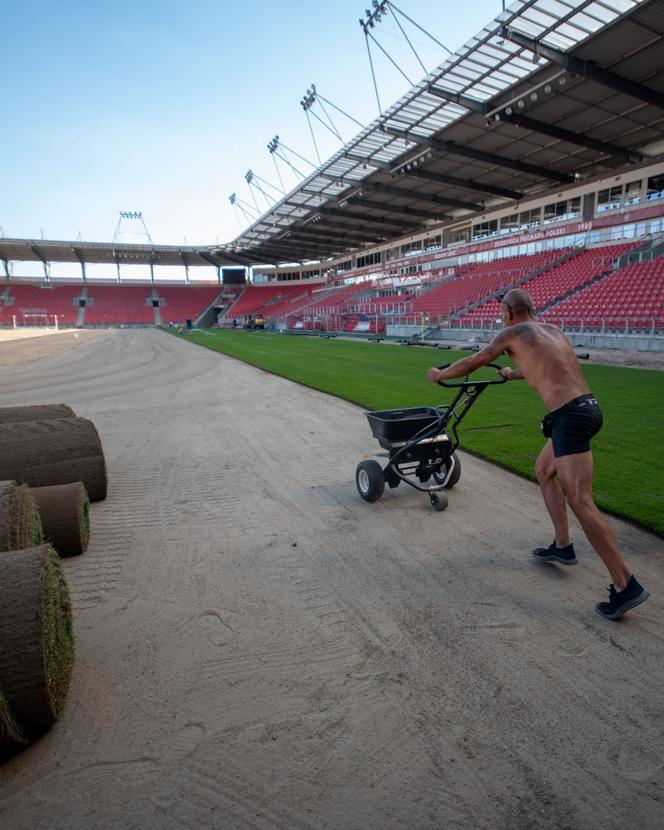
[552,450,630,591]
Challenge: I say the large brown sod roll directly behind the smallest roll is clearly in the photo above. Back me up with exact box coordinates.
[0,418,107,501]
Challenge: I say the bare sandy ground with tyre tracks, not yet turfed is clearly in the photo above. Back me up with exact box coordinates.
[0,331,664,830]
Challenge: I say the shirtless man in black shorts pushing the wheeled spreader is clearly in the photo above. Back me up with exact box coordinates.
[427,288,649,620]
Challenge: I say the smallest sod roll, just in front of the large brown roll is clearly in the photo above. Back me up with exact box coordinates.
[30,481,90,556]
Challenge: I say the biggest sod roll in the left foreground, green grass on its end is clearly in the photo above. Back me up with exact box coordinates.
[0,545,74,740]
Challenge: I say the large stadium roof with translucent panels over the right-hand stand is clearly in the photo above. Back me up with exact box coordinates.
[224,0,664,263]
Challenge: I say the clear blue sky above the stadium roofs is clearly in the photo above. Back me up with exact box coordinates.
[0,0,502,244]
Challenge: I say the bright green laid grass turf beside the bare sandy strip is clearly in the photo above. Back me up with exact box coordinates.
[176,329,664,536]
